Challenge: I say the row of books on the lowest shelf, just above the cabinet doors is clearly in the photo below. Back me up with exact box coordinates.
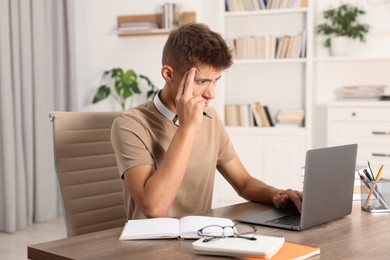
[225,102,305,127]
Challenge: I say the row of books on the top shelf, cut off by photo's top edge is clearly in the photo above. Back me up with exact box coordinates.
[225,0,307,12]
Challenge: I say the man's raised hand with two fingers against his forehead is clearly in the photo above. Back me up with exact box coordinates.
[175,68,204,132]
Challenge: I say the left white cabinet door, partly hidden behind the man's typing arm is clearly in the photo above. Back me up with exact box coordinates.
[213,134,263,208]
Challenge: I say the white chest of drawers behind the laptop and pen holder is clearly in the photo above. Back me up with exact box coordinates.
[327,100,390,178]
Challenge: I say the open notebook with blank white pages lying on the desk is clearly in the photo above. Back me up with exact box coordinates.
[119,216,234,240]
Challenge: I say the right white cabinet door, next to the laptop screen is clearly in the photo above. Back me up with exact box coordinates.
[263,136,305,190]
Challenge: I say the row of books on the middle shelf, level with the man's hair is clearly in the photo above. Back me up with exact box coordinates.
[226,31,306,59]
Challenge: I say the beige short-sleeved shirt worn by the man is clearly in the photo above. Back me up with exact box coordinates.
[111,101,236,219]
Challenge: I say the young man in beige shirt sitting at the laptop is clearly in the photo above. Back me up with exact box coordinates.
[111,23,302,219]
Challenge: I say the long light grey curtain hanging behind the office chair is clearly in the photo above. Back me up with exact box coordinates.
[0,0,76,232]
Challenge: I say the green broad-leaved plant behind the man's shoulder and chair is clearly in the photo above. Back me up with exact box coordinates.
[92,68,158,110]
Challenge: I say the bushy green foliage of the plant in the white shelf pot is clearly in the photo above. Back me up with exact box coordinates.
[317,4,369,47]
